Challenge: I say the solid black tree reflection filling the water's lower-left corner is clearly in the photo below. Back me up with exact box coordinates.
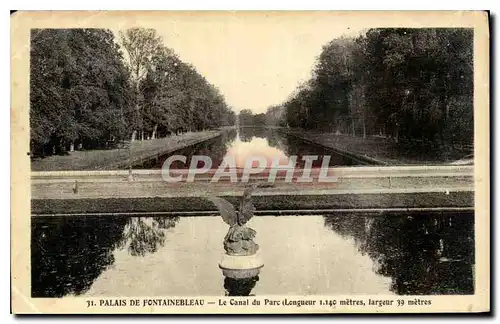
[31,217,126,297]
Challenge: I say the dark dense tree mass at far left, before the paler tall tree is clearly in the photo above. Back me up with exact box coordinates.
[30,29,132,155]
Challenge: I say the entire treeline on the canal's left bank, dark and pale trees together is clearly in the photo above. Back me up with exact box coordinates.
[30,28,236,155]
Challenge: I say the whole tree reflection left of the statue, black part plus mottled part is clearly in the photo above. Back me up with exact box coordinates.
[31,216,179,297]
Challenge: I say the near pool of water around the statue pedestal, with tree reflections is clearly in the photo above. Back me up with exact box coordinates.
[31,213,474,297]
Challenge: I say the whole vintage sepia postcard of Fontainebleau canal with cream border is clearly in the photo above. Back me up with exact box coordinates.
[11,11,490,314]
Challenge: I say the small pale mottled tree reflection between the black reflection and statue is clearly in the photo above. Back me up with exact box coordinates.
[120,217,179,256]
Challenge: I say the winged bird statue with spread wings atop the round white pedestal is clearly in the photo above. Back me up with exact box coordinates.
[208,187,259,256]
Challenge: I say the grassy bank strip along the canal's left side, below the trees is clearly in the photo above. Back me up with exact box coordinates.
[31,130,220,171]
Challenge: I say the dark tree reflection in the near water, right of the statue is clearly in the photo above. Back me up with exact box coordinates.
[325,214,474,295]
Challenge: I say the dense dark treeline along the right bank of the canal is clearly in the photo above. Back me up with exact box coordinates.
[280,28,473,144]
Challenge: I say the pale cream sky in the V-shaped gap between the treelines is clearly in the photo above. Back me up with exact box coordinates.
[115,12,366,114]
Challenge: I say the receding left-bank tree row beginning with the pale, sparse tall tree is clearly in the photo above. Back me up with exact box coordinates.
[120,28,236,139]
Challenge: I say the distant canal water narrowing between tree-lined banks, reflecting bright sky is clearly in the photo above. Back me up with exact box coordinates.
[134,127,363,169]
